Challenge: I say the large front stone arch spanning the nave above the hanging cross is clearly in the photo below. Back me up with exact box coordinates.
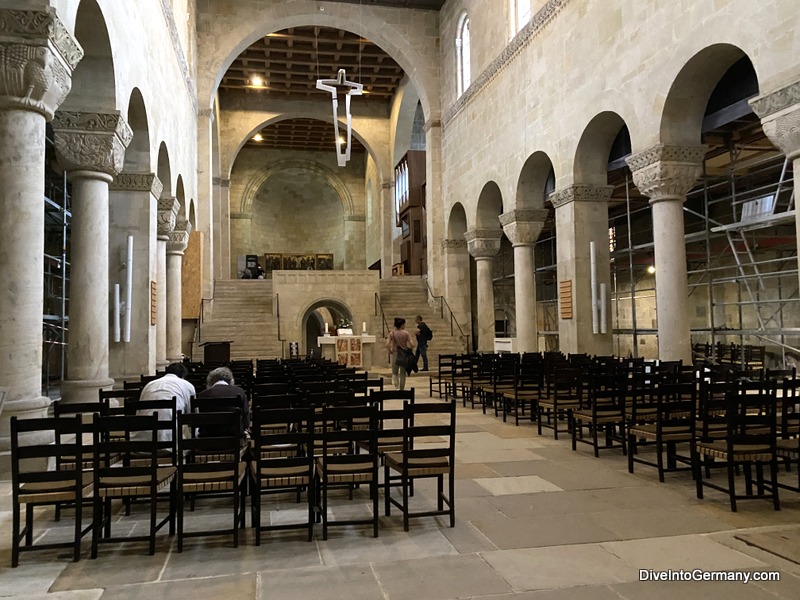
[198,0,440,119]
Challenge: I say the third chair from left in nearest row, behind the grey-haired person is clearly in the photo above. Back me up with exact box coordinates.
[176,410,247,552]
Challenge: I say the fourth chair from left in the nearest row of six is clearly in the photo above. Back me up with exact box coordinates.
[250,408,314,546]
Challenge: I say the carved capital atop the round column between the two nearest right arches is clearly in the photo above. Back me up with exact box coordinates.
[626,144,708,204]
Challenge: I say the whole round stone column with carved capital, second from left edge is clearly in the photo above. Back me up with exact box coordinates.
[53,111,133,402]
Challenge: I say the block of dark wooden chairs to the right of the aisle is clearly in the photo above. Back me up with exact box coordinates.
[431,353,800,511]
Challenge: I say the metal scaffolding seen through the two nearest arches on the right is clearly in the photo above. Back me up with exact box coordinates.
[609,144,800,364]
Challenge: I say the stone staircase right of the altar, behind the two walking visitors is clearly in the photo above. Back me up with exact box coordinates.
[380,275,466,369]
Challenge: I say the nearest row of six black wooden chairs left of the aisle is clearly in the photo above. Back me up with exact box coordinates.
[12,390,455,566]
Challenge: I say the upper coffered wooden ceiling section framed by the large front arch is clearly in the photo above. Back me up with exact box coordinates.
[220,26,403,103]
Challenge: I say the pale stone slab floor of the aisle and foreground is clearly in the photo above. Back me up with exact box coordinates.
[0,376,800,600]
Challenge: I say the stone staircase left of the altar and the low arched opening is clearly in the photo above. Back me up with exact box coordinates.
[192,279,281,360]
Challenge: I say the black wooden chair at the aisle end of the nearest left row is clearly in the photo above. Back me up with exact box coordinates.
[383,402,456,531]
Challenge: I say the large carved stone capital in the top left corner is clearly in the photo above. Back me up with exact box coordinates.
[0,8,83,120]
